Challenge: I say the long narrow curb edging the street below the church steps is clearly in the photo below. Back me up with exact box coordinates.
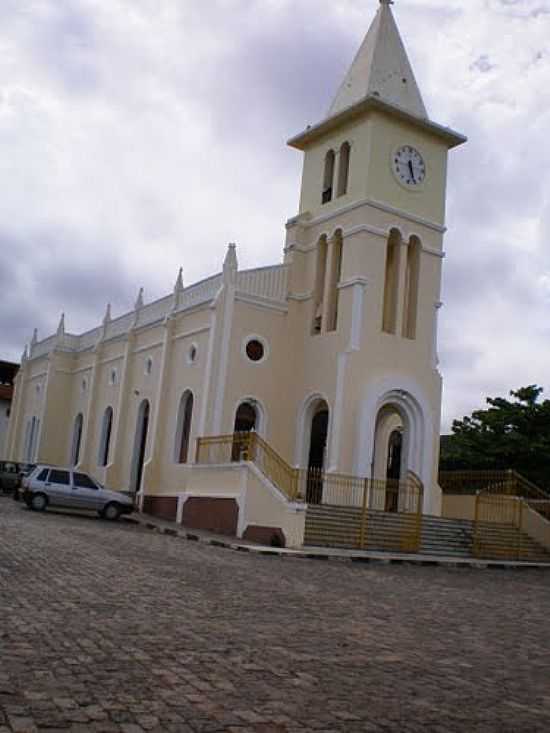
[124,517,550,570]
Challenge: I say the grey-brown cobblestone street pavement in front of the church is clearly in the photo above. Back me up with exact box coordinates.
[0,498,550,733]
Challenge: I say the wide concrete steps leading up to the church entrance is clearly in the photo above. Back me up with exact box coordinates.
[305,505,550,563]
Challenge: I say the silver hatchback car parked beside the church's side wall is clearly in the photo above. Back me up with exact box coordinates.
[22,465,134,520]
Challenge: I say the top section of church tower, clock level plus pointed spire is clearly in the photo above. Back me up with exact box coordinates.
[289,0,465,225]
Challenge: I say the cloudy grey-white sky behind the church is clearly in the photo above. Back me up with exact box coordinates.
[0,0,550,425]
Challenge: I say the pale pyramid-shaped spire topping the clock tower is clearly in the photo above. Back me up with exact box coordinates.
[328,0,428,118]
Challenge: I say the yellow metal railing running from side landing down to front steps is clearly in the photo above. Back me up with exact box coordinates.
[196,432,424,552]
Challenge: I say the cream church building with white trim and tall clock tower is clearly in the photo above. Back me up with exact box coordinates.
[6,0,465,546]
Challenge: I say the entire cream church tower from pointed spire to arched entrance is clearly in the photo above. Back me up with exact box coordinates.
[285,0,466,514]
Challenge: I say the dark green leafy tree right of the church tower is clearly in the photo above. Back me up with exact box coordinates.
[440,385,550,489]
